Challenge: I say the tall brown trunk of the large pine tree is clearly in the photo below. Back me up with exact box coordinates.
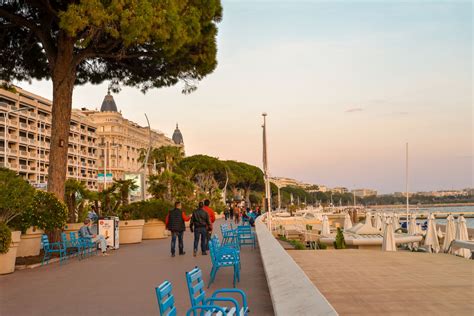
[48,36,76,201]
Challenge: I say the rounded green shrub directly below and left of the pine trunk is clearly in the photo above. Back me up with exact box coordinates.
[25,190,68,232]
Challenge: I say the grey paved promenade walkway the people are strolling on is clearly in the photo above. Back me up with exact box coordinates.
[0,222,273,316]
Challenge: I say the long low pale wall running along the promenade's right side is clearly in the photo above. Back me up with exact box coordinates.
[255,216,338,316]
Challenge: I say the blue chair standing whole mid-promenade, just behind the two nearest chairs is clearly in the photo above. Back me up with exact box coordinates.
[207,237,240,288]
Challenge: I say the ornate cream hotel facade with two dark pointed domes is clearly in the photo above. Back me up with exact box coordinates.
[79,93,184,187]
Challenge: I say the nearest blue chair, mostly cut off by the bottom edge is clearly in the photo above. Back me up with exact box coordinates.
[155,281,226,316]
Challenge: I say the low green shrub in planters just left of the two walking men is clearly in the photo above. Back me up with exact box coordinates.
[119,199,173,221]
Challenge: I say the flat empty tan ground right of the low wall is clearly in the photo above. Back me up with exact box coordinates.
[288,250,474,315]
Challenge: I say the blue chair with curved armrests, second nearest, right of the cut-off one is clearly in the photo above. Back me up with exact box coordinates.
[186,267,249,315]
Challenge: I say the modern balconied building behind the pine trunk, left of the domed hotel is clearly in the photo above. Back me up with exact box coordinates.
[0,87,97,190]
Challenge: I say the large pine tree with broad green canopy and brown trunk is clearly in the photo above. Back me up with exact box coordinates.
[0,0,222,199]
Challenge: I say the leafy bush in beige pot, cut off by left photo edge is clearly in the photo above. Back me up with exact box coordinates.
[0,168,35,274]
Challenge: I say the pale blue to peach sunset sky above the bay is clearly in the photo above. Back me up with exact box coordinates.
[19,0,474,193]
